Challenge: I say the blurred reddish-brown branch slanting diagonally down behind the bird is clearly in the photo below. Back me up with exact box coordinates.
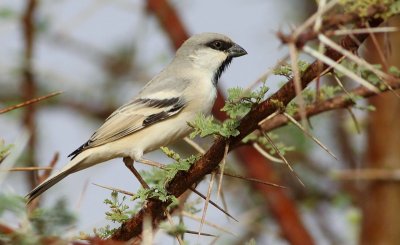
[147,0,314,245]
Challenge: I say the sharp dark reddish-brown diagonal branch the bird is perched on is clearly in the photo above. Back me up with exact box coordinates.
[112,15,382,242]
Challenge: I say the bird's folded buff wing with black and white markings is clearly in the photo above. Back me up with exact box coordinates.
[69,96,186,157]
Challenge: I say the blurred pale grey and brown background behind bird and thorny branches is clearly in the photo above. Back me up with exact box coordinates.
[0,0,400,244]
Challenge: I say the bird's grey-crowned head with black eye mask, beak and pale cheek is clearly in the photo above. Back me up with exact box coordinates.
[176,33,247,84]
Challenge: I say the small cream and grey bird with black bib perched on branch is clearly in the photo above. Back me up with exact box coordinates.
[26,32,247,204]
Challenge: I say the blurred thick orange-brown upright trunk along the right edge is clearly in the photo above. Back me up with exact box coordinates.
[361,18,400,245]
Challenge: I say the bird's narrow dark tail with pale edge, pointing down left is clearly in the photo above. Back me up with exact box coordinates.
[25,154,85,204]
